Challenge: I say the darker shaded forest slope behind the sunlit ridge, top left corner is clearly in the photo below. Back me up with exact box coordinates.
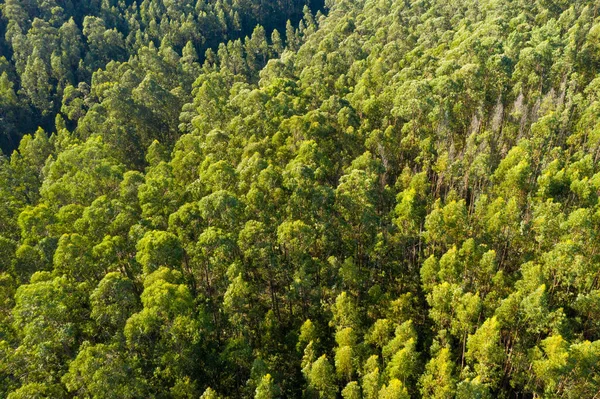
[0,0,323,154]
